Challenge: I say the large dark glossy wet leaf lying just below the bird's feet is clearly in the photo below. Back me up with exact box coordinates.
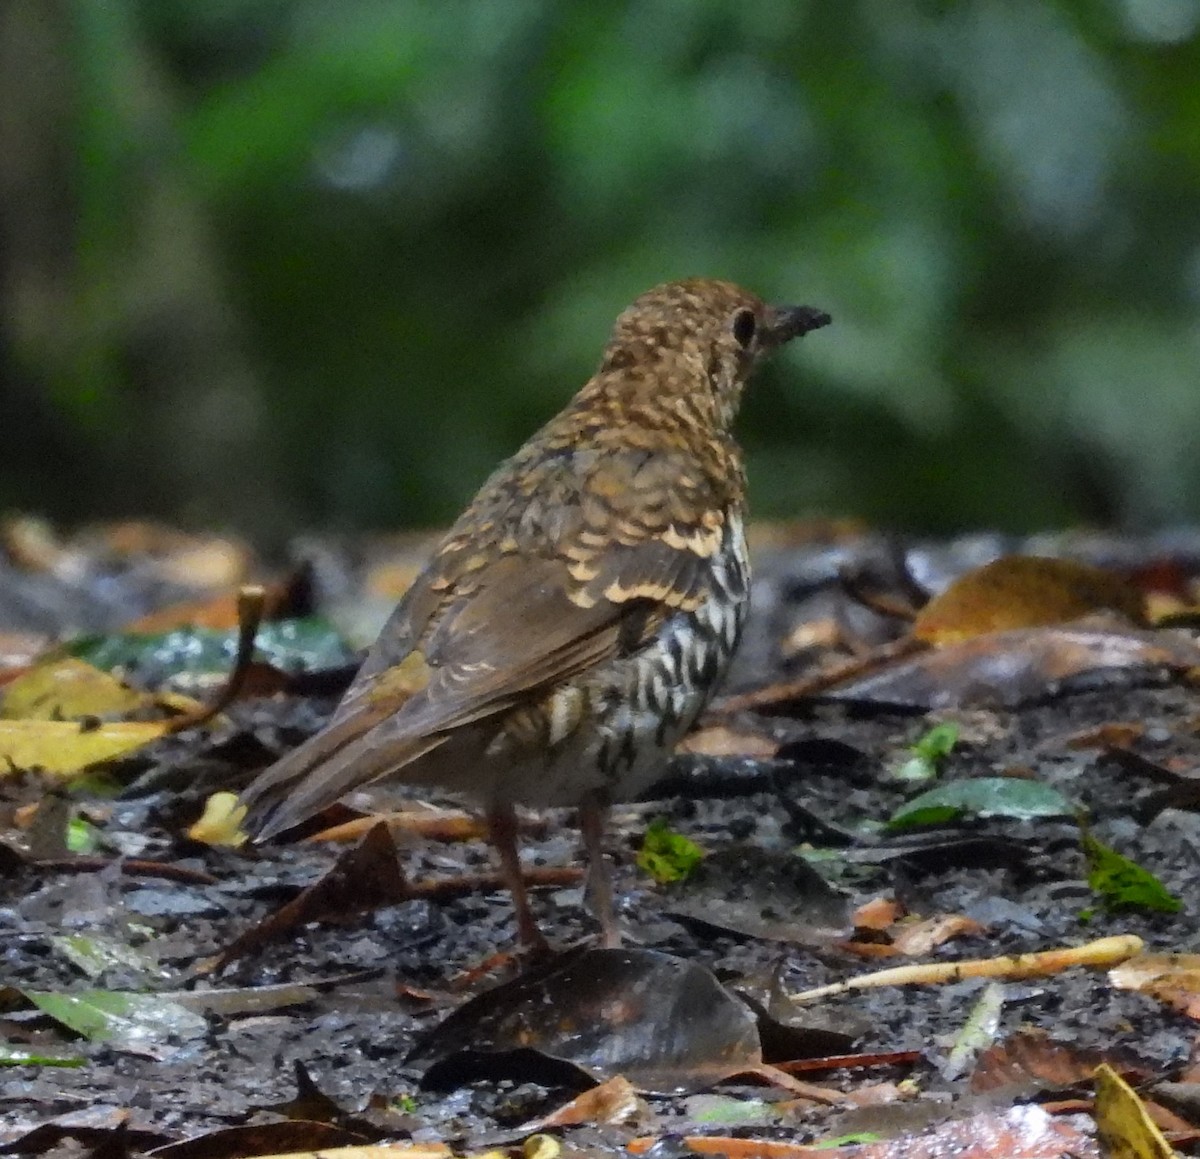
[407,949,762,1094]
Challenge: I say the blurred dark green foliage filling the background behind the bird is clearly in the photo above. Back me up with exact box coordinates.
[0,0,1200,535]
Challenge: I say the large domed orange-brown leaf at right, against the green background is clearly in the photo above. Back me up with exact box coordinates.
[912,556,1146,644]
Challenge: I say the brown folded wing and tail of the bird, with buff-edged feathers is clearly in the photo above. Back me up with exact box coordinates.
[244,448,726,836]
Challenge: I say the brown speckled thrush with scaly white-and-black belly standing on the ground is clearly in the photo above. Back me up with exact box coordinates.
[242,278,829,945]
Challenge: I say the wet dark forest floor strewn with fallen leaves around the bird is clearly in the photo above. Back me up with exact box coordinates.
[0,528,1200,1159]
